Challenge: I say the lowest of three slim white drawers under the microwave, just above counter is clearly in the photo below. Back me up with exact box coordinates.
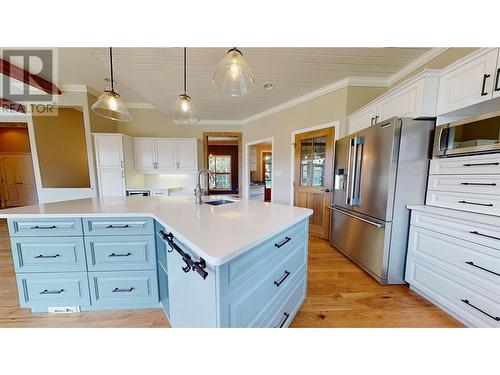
[426,190,500,216]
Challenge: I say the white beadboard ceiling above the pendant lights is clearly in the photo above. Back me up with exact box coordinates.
[54,47,430,122]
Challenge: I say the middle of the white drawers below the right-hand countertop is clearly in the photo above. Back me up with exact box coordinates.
[408,226,500,300]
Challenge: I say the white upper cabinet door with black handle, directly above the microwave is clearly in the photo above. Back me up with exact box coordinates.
[437,49,498,115]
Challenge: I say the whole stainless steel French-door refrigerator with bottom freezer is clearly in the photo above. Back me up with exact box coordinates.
[330,118,434,284]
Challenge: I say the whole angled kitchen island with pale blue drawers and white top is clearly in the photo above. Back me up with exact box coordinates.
[0,197,312,327]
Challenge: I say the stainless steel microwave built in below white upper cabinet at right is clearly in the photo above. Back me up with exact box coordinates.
[433,111,500,158]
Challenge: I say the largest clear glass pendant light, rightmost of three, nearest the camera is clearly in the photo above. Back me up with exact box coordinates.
[212,47,255,96]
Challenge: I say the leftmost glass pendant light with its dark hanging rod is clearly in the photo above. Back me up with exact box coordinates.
[91,47,132,121]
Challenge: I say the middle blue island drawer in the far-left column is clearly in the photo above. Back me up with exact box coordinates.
[10,237,87,273]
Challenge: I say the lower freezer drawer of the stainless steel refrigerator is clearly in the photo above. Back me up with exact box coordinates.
[330,207,390,284]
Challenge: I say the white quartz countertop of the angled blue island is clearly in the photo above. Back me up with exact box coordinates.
[0,196,312,265]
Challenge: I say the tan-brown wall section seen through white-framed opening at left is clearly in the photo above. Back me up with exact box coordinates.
[33,108,90,188]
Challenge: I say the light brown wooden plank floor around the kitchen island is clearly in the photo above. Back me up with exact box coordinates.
[0,220,462,327]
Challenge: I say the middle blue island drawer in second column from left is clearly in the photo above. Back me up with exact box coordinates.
[85,235,156,271]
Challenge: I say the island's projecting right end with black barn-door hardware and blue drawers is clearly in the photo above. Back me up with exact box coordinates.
[157,219,308,328]
